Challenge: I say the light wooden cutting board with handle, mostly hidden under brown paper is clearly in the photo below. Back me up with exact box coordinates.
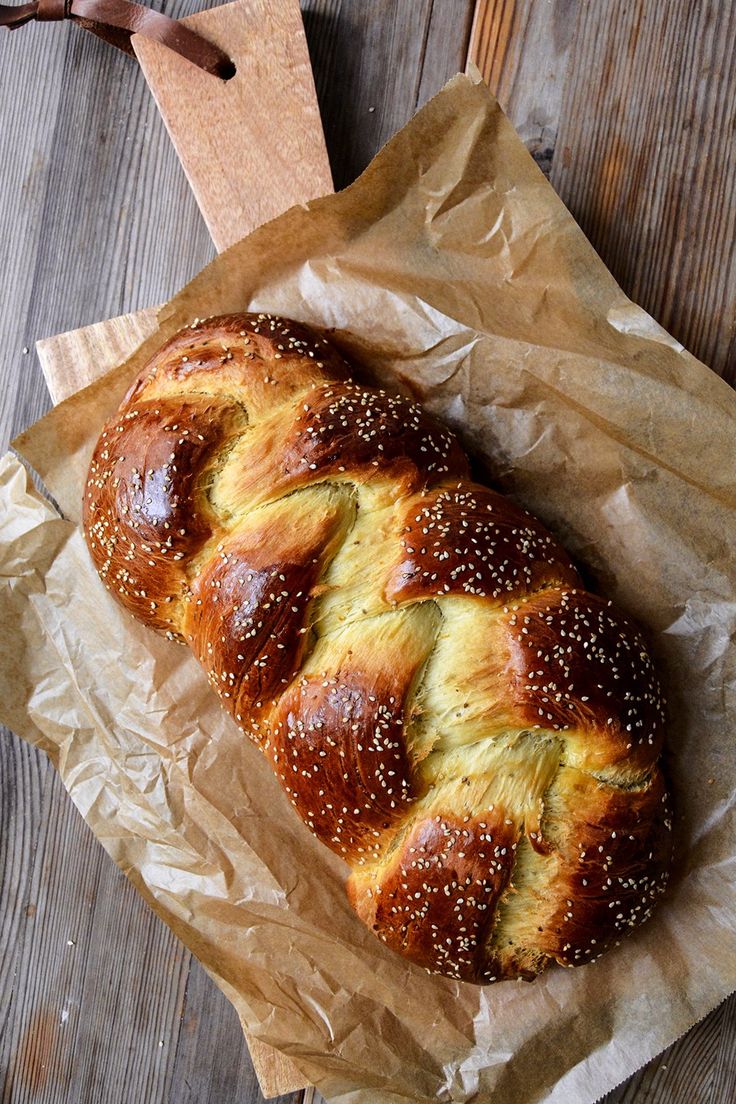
[36,0,332,1097]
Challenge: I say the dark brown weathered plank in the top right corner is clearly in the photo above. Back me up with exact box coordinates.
[551,0,736,383]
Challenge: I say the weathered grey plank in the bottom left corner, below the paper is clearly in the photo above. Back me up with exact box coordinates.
[0,736,190,1104]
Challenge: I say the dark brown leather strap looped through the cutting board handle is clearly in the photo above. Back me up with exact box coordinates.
[0,0,235,81]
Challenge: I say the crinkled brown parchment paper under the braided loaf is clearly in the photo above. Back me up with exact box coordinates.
[0,77,736,1104]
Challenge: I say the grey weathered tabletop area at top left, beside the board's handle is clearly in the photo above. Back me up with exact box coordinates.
[0,14,214,440]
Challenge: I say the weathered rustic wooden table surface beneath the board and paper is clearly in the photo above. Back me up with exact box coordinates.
[0,0,736,1104]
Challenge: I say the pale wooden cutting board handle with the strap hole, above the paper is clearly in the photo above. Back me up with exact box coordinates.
[134,0,332,252]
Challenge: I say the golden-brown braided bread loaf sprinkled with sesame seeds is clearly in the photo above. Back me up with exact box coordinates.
[85,315,670,983]
